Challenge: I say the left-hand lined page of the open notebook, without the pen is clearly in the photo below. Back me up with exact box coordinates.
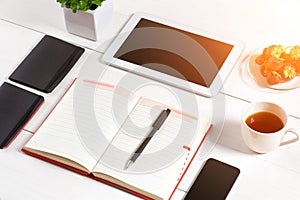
[25,80,138,171]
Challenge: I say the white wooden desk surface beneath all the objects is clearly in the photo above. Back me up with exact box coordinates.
[0,0,300,200]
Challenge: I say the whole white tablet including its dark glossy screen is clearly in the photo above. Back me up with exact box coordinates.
[103,13,244,97]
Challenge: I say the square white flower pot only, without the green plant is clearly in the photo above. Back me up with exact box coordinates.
[64,0,113,40]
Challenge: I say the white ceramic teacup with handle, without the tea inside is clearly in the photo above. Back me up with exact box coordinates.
[241,102,299,153]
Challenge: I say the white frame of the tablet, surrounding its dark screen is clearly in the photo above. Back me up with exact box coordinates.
[103,13,244,97]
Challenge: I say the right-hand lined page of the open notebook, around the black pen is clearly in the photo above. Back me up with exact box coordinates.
[93,99,210,198]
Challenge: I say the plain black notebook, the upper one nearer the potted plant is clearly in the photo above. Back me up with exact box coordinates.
[9,35,84,93]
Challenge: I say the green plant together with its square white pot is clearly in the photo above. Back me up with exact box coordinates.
[57,0,113,40]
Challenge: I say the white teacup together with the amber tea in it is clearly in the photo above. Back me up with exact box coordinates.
[241,102,299,153]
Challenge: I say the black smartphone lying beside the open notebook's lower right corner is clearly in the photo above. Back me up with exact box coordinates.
[185,158,240,200]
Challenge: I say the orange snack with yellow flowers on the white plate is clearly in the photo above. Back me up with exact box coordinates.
[255,45,300,85]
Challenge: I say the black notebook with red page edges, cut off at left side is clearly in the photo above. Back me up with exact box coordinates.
[0,83,44,149]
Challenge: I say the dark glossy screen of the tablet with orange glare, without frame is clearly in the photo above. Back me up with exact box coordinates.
[114,18,233,87]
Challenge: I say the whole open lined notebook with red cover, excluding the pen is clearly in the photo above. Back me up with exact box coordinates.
[23,80,211,199]
